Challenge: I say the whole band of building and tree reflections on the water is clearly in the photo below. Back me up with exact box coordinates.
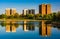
[0,20,59,36]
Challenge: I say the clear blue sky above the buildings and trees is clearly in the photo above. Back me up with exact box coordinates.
[0,0,60,14]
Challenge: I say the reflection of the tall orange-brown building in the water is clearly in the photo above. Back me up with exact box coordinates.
[39,21,51,36]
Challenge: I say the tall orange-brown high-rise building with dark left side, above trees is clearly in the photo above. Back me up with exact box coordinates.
[39,4,51,16]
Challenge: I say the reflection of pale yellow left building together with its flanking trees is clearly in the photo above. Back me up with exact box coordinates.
[0,21,19,32]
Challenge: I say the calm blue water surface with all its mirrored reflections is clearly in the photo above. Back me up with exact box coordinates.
[0,21,60,39]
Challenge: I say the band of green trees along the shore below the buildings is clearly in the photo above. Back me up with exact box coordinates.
[0,12,60,20]
